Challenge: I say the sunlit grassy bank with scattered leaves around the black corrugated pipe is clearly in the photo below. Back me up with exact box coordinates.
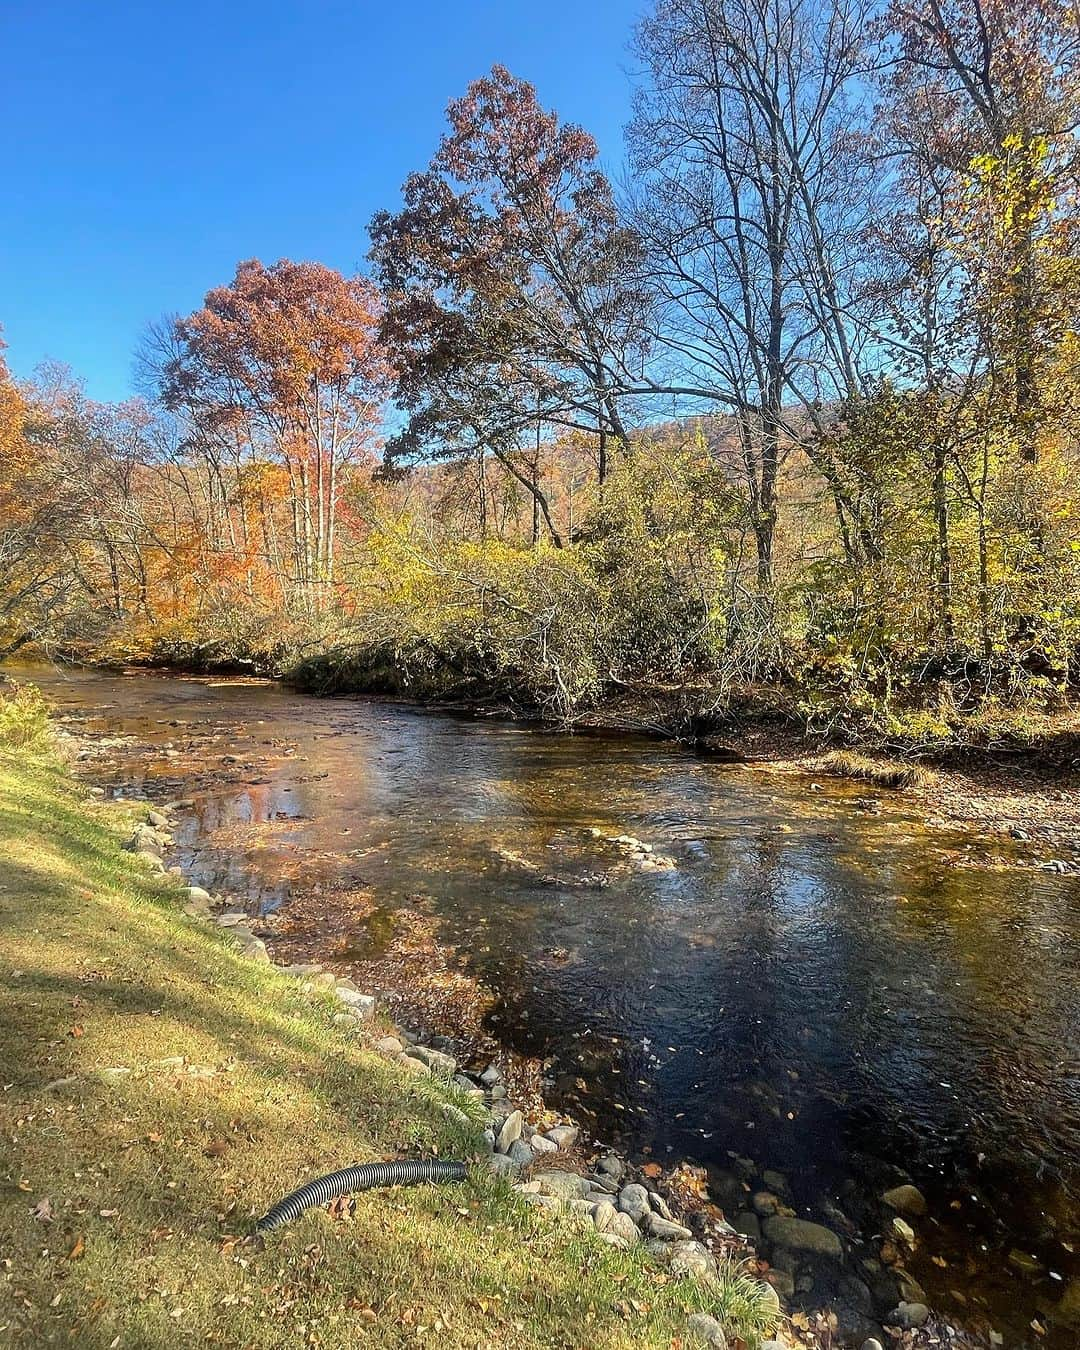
[0,749,783,1350]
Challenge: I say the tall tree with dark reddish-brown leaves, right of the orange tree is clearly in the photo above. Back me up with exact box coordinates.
[371,66,645,543]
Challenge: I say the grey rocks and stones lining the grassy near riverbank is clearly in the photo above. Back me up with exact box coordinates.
[118,790,992,1350]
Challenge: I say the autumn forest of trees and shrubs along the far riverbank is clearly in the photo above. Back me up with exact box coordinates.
[0,0,1080,748]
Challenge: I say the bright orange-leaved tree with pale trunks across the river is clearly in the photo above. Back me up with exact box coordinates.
[161,259,389,601]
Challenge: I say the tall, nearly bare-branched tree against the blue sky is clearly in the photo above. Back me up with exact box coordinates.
[629,0,869,594]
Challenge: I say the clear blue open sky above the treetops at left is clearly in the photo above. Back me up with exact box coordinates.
[0,0,644,400]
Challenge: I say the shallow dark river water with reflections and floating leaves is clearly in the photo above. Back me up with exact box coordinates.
[18,670,1080,1347]
